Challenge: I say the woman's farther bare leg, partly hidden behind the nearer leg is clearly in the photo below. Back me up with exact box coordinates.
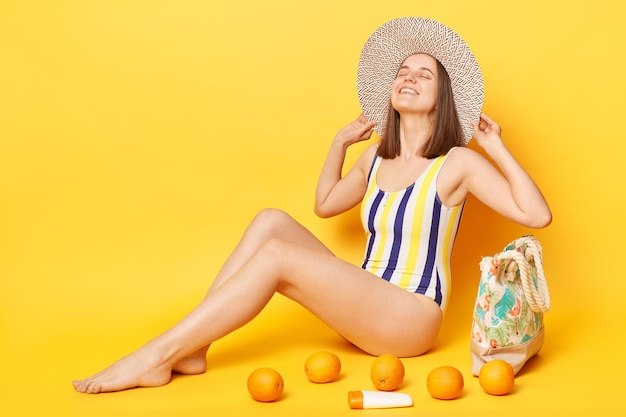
[173,209,331,375]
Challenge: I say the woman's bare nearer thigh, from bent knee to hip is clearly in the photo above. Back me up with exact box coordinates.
[273,241,443,357]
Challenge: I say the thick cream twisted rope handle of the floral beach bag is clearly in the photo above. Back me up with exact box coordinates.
[496,236,550,313]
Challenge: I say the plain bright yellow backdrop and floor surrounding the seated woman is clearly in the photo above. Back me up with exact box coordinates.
[0,0,626,416]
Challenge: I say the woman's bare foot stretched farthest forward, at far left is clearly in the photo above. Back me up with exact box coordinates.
[73,351,172,394]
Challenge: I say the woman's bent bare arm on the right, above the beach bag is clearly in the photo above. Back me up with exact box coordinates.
[446,114,552,228]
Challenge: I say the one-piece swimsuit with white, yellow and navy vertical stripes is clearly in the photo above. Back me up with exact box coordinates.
[361,151,464,310]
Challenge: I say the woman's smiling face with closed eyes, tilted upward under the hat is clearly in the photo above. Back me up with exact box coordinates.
[391,54,438,115]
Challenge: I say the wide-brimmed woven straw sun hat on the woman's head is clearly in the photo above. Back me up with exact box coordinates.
[357,17,484,144]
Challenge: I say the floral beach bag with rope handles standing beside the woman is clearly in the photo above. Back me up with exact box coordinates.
[471,235,550,375]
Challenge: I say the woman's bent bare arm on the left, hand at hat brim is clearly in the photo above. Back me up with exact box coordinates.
[314,114,375,217]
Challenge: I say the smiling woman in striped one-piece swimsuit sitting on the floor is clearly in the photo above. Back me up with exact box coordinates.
[74,18,551,393]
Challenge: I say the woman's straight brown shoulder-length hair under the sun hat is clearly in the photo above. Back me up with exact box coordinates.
[377,60,463,159]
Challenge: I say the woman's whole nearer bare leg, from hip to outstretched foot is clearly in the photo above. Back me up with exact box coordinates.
[74,210,442,393]
